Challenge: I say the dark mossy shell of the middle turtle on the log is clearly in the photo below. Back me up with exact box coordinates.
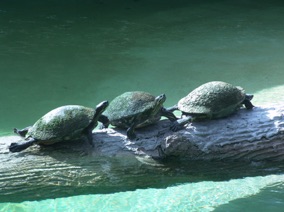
[104,91,162,128]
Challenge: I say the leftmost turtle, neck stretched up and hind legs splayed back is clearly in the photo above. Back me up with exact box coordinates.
[9,101,109,152]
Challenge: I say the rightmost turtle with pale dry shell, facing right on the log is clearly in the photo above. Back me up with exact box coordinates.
[167,81,254,131]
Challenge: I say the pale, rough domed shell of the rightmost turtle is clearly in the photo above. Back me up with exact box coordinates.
[178,81,246,118]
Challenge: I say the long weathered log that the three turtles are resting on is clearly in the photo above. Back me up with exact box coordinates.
[0,105,284,202]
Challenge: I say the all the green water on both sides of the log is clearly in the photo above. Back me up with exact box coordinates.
[0,0,284,211]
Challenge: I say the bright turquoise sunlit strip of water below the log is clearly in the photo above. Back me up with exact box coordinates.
[0,175,284,212]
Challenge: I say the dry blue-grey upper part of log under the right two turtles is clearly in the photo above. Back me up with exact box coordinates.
[94,105,284,161]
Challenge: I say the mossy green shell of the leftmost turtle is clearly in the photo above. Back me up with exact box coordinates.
[26,105,95,144]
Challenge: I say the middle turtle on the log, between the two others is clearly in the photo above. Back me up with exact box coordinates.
[102,91,177,140]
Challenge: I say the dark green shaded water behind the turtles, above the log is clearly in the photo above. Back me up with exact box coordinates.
[0,0,284,132]
